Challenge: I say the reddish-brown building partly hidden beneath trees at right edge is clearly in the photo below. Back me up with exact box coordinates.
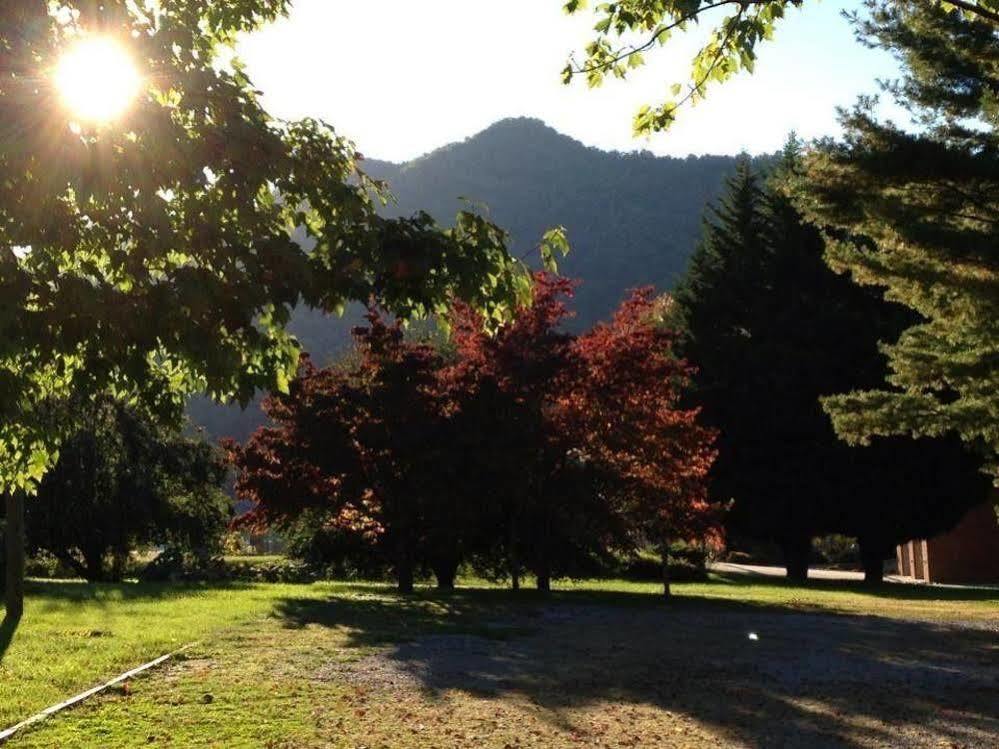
[897,498,999,583]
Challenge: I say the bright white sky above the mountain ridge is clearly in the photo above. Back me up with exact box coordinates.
[239,0,897,161]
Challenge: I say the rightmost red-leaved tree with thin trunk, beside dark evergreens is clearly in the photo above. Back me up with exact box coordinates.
[559,288,719,596]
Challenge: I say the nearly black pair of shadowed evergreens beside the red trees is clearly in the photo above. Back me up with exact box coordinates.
[676,145,984,580]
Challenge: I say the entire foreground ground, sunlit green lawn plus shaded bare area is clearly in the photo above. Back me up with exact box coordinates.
[0,579,999,749]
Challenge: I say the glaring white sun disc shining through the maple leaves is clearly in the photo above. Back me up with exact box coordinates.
[54,36,142,124]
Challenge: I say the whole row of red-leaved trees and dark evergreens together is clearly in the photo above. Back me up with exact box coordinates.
[230,136,988,590]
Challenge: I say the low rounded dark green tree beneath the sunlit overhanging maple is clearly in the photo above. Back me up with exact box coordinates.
[8,398,231,581]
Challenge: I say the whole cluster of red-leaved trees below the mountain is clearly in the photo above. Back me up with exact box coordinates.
[228,272,719,594]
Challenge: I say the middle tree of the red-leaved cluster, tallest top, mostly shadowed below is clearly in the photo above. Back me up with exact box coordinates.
[442,273,616,590]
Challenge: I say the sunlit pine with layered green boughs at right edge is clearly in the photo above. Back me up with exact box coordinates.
[801,0,999,480]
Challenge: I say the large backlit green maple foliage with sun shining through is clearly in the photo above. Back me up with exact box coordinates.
[0,0,529,489]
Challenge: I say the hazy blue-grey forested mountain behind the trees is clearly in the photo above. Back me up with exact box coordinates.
[190,118,735,439]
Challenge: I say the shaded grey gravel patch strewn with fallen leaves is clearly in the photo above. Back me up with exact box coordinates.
[316,605,999,749]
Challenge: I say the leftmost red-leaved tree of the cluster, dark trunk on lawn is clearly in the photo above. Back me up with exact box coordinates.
[227,312,457,592]
